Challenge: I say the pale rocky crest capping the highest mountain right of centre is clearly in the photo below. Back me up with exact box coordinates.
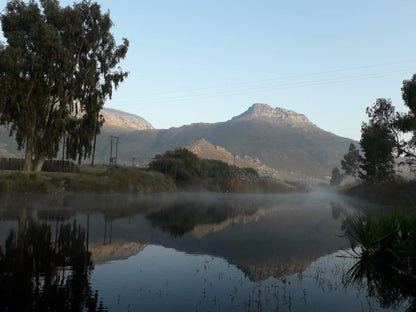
[233,103,312,126]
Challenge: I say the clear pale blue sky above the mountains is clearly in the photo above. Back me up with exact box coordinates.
[0,0,416,140]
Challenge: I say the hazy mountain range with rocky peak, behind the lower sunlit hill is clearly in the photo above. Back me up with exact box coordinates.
[0,103,352,183]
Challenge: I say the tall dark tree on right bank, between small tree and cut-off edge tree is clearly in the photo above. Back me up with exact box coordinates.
[360,99,397,183]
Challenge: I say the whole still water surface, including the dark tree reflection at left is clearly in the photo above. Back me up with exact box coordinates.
[0,192,407,311]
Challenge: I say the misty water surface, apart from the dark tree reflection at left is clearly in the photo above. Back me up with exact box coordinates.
[0,190,400,311]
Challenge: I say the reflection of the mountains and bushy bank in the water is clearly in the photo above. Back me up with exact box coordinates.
[0,194,353,281]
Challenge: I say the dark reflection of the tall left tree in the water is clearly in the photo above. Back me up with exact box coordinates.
[0,220,106,311]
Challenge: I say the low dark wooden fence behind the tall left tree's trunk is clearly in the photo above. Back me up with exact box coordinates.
[0,158,79,172]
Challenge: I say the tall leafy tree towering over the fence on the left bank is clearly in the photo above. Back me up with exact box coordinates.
[0,0,128,170]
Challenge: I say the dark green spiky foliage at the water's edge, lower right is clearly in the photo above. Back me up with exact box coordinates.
[346,213,416,311]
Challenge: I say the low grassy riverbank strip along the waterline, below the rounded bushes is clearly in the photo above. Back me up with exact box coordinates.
[0,166,304,194]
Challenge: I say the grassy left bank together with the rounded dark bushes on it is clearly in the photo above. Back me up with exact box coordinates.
[0,149,306,194]
